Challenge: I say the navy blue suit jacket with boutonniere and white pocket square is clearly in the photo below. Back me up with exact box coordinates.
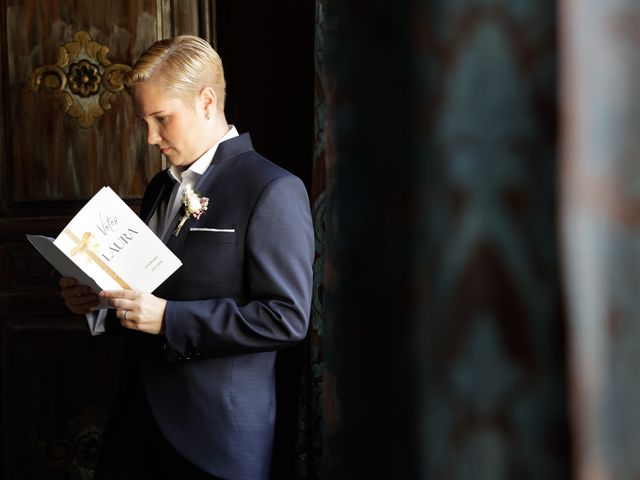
[109,134,314,479]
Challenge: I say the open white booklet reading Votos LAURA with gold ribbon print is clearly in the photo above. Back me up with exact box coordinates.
[27,187,182,308]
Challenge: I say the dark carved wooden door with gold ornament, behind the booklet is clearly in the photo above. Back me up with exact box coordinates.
[0,0,215,480]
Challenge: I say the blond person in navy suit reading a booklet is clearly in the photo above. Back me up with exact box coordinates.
[60,35,314,480]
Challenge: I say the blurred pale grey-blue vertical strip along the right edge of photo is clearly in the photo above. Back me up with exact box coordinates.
[561,0,640,480]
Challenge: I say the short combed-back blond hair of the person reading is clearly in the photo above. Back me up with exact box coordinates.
[124,35,225,110]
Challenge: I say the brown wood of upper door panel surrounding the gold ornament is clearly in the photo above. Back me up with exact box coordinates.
[4,0,161,203]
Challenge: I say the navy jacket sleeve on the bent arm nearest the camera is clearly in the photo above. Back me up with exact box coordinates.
[165,176,314,356]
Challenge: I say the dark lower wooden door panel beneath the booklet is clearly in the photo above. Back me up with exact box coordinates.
[0,315,119,479]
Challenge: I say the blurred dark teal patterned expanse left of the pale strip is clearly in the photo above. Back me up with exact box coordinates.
[319,0,571,480]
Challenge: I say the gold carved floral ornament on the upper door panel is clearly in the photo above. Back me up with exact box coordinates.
[27,31,131,128]
